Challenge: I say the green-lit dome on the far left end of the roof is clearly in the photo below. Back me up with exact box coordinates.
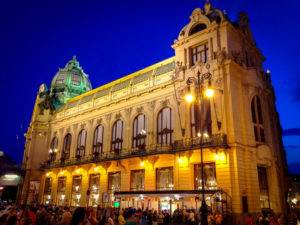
[50,56,92,108]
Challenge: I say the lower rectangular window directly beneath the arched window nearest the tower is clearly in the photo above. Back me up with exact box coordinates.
[156,167,174,191]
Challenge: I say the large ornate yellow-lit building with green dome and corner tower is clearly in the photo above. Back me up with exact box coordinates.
[23,1,287,224]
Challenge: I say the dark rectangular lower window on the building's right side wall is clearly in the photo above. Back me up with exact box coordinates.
[257,166,270,209]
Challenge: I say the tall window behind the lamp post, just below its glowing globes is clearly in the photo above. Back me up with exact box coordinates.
[191,98,212,138]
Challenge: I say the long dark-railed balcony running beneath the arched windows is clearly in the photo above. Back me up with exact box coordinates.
[40,134,228,169]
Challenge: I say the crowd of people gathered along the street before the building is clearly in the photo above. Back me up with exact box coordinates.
[0,205,297,225]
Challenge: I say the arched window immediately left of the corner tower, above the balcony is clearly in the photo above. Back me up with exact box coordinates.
[157,108,174,144]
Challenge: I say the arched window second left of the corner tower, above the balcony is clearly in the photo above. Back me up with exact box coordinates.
[132,114,147,149]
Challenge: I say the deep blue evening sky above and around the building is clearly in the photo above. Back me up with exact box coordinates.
[0,0,300,173]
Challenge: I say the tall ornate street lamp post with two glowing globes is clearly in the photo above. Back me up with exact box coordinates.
[185,71,214,225]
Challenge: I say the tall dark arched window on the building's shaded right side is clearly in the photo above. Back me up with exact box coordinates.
[251,96,265,142]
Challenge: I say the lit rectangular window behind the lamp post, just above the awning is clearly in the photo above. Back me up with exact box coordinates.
[194,163,217,190]
